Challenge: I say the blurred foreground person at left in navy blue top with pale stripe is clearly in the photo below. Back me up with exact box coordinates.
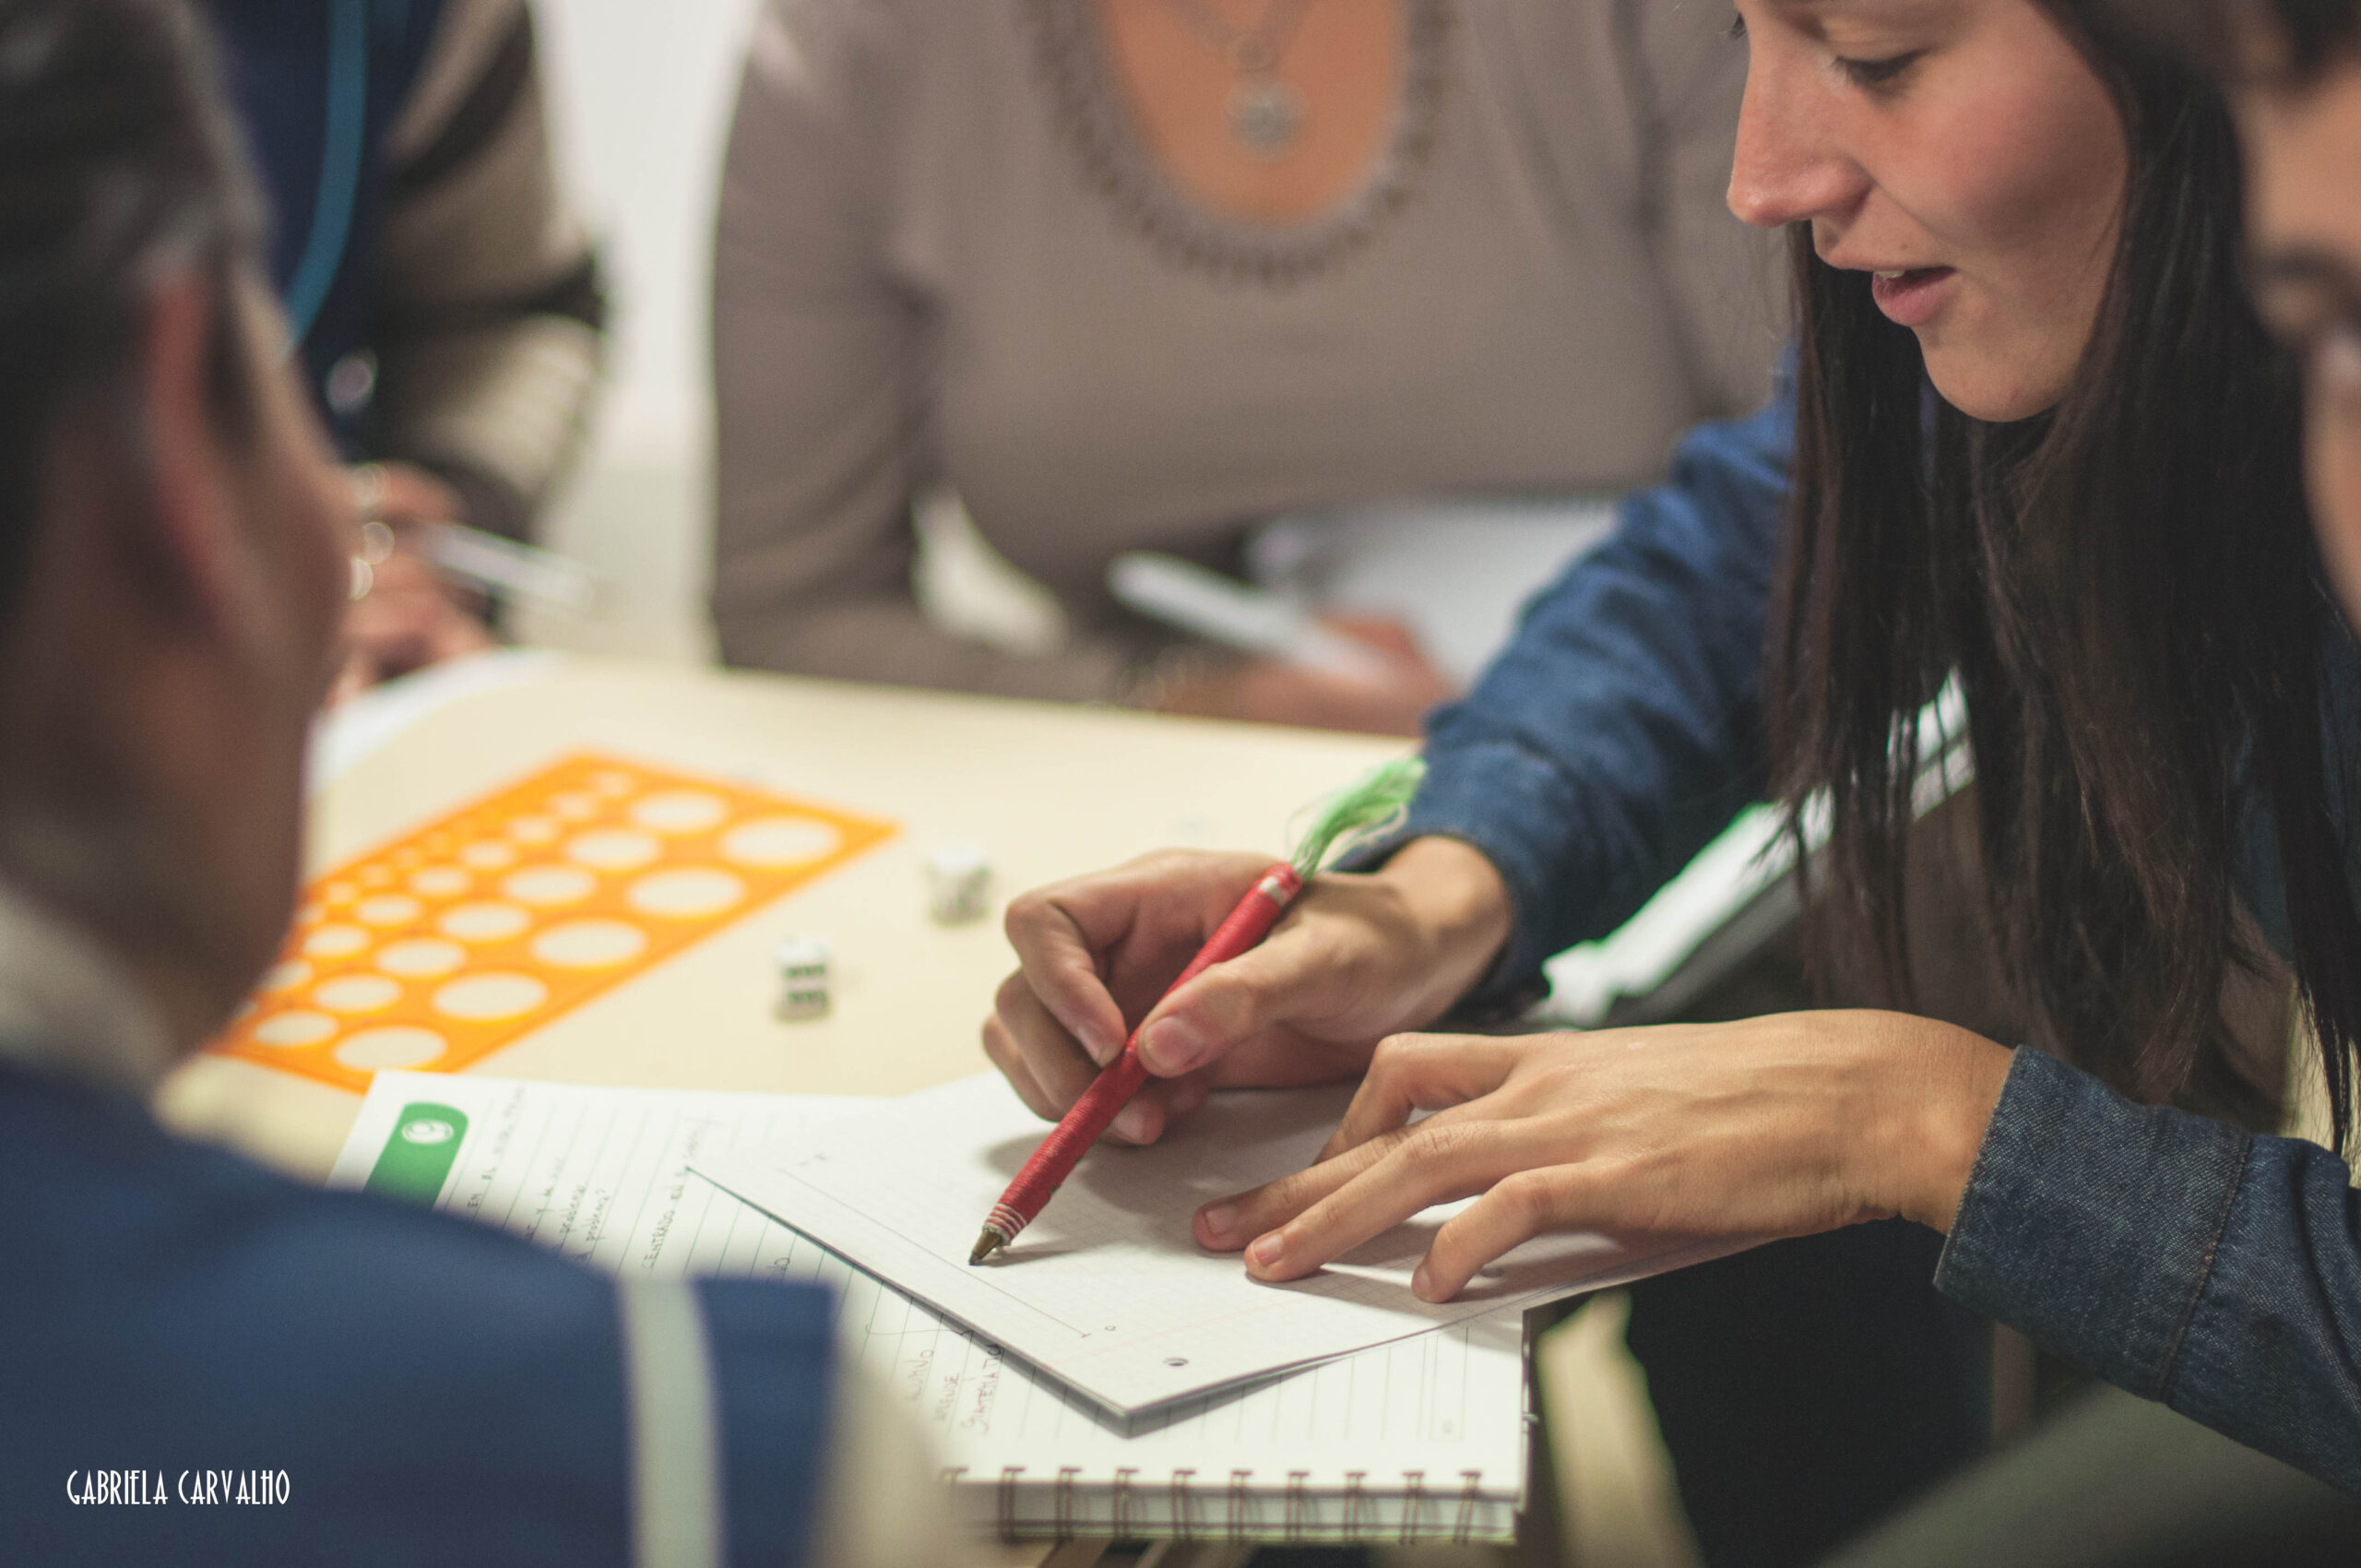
[0,0,961,1568]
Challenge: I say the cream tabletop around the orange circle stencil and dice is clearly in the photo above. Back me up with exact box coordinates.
[159,659,1403,1181]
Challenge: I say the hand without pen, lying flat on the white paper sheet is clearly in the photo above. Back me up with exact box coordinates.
[1197,1013,2010,1301]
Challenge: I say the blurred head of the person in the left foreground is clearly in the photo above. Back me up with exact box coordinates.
[0,0,347,1072]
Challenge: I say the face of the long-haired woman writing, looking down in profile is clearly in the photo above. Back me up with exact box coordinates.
[1730,0,2130,421]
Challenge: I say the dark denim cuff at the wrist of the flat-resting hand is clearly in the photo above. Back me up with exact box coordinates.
[1934,1046,2252,1398]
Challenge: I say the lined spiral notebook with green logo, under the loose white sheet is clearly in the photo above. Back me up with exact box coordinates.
[330,1072,1527,1542]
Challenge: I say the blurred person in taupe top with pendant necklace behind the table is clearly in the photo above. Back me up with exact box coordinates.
[713,0,1780,734]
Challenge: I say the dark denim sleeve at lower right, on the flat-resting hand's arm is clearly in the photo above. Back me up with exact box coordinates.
[1936,1049,2361,1492]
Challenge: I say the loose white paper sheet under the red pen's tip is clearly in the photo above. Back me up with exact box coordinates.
[692,1075,1747,1415]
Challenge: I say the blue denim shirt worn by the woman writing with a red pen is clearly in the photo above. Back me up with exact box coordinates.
[1355,361,2361,1492]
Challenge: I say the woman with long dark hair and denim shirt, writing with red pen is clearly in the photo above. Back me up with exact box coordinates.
[985,0,2361,1561]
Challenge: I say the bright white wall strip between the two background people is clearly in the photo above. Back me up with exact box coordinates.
[517,0,755,659]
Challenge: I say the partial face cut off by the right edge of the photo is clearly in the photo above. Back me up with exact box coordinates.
[2234,59,2361,624]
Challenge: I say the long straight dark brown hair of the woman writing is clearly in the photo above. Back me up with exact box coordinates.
[1766,0,2361,1141]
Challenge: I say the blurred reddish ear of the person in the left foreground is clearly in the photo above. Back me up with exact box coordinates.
[118,269,253,625]
